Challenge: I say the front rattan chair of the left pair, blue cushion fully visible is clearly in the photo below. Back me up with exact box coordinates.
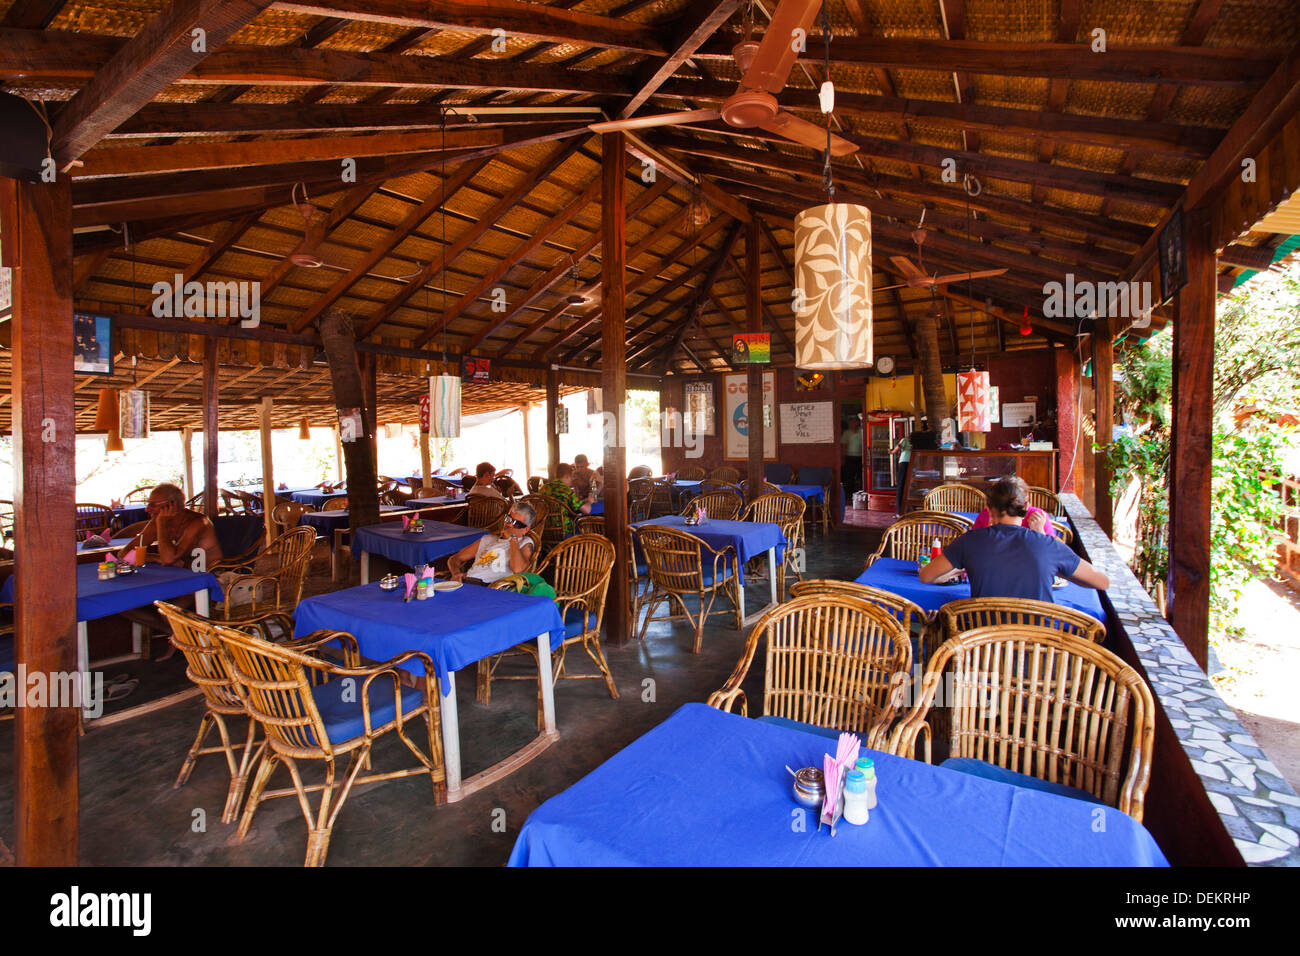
[212,616,446,866]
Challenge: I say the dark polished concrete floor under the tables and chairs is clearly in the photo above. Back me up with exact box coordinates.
[0,527,880,866]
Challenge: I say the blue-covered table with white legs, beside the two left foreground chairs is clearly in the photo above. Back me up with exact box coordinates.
[294,581,564,803]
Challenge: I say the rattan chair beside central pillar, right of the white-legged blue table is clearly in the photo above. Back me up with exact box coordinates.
[477,535,619,728]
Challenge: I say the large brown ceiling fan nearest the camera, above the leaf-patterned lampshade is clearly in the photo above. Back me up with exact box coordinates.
[589,0,858,156]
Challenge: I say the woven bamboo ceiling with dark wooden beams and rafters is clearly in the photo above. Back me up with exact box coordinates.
[0,0,1300,408]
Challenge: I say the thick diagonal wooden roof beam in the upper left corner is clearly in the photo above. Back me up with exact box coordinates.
[48,0,270,169]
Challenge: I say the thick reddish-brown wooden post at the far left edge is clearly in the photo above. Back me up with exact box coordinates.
[0,176,83,866]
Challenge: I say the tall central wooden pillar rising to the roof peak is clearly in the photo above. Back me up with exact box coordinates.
[598,133,632,644]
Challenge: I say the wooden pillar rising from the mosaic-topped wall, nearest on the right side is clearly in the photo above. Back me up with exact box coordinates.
[1166,209,1217,669]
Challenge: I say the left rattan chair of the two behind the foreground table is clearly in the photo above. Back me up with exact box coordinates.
[709,592,911,749]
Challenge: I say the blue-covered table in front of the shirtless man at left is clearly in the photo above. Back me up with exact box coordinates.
[0,563,224,712]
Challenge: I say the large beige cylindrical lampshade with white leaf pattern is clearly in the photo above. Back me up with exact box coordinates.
[794,203,874,371]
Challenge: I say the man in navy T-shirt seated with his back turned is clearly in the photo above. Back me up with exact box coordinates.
[920,477,1110,604]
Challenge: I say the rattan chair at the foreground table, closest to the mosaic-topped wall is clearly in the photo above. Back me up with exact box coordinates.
[889,624,1156,822]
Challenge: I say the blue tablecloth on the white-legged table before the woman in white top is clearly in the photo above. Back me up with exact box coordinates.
[294,583,564,693]
